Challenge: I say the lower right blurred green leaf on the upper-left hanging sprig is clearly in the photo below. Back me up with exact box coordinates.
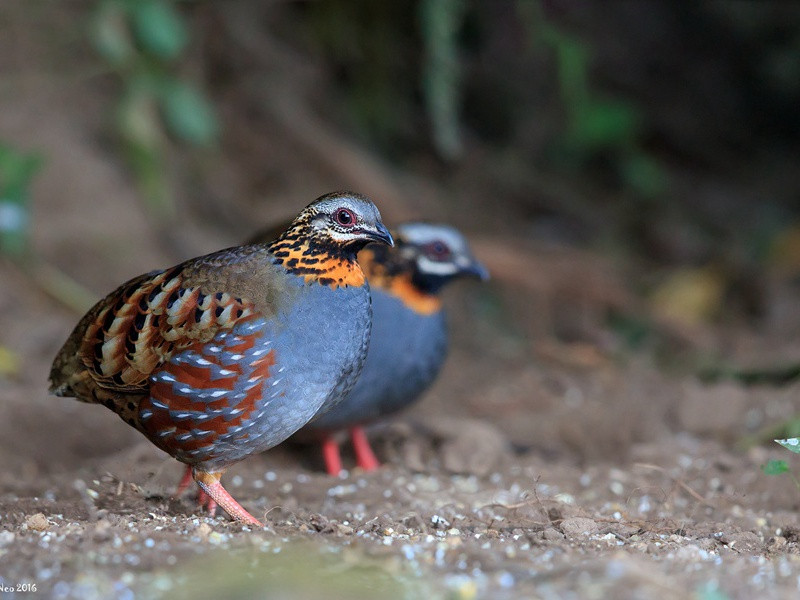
[161,81,219,145]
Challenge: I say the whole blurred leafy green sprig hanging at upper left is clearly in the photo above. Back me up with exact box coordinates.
[91,0,219,220]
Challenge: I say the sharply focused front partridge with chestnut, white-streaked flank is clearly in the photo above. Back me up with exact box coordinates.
[50,192,393,527]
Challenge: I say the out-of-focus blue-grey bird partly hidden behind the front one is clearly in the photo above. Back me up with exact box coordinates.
[272,222,489,476]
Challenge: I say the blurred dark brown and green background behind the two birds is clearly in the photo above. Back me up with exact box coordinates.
[0,0,800,418]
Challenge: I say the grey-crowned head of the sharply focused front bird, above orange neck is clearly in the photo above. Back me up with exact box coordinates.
[284,192,394,254]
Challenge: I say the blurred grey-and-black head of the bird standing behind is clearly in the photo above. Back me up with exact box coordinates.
[397,223,489,289]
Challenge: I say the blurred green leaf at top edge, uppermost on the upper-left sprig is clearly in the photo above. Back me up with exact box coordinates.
[132,0,189,60]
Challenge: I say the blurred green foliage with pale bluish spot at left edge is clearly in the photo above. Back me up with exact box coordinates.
[0,143,43,257]
